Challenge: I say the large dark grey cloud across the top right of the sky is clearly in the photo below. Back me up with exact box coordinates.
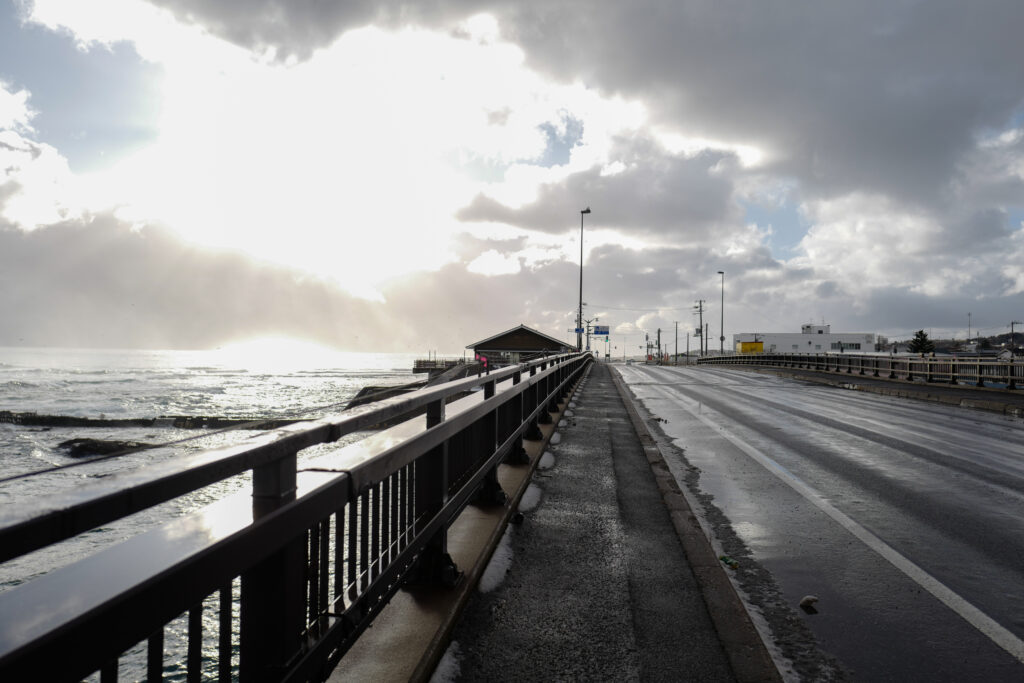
[149,0,1024,209]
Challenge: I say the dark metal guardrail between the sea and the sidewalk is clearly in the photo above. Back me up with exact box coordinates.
[0,354,592,683]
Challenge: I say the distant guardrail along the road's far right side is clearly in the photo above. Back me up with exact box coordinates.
[697,353,1024,389]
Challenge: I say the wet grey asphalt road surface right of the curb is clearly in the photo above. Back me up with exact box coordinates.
[620,366,1024,681]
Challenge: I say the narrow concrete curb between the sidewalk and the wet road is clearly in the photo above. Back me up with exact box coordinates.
[609,368,782,683]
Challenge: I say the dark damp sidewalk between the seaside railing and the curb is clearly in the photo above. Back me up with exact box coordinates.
[437,364,780,681]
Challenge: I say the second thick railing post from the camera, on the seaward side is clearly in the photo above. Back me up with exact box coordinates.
[410,398,462,588]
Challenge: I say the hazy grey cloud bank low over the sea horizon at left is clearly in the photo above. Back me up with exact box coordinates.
[0,216,384,348]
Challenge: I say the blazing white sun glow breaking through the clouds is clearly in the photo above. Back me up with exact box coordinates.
[25,0,655,299]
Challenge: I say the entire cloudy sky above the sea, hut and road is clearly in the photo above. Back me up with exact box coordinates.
[0,0,1024,353]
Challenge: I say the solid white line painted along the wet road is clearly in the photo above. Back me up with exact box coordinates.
[652,386,1024,663]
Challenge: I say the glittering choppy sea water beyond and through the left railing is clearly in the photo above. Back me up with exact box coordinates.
[0,347,440,680]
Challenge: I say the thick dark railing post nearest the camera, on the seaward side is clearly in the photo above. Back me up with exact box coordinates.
[239,453,306,681]
